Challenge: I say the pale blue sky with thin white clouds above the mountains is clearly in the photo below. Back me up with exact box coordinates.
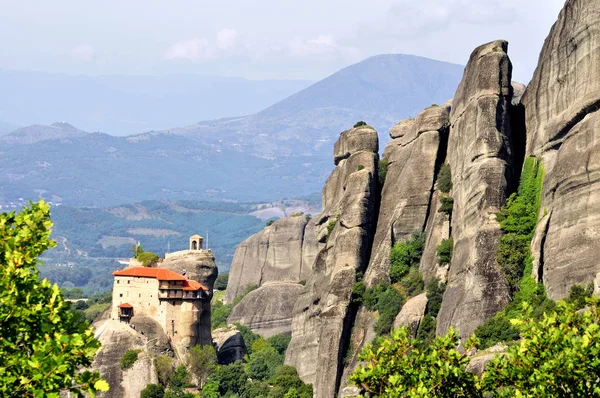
[0,0,564,83]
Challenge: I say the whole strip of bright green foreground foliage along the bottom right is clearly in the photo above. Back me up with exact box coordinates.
[350,297,600,398]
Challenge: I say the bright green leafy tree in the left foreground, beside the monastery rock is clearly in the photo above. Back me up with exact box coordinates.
[0,201,108,397]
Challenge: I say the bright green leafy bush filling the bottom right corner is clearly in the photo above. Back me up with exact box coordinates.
[482,297,600,397]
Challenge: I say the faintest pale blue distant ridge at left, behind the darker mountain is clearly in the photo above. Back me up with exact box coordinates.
[0,70,311,135]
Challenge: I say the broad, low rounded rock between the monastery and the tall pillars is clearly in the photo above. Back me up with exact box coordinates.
[224,215,324,337]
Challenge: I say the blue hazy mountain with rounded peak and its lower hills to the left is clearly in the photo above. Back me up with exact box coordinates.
[0,55,463,206]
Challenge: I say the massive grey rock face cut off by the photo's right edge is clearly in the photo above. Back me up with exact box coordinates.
[523,0,600,299]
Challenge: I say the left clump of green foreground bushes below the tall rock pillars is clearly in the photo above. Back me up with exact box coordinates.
[350,328,482,398]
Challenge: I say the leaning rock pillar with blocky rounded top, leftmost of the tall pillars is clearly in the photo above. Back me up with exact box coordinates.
[286,127,378,398]
